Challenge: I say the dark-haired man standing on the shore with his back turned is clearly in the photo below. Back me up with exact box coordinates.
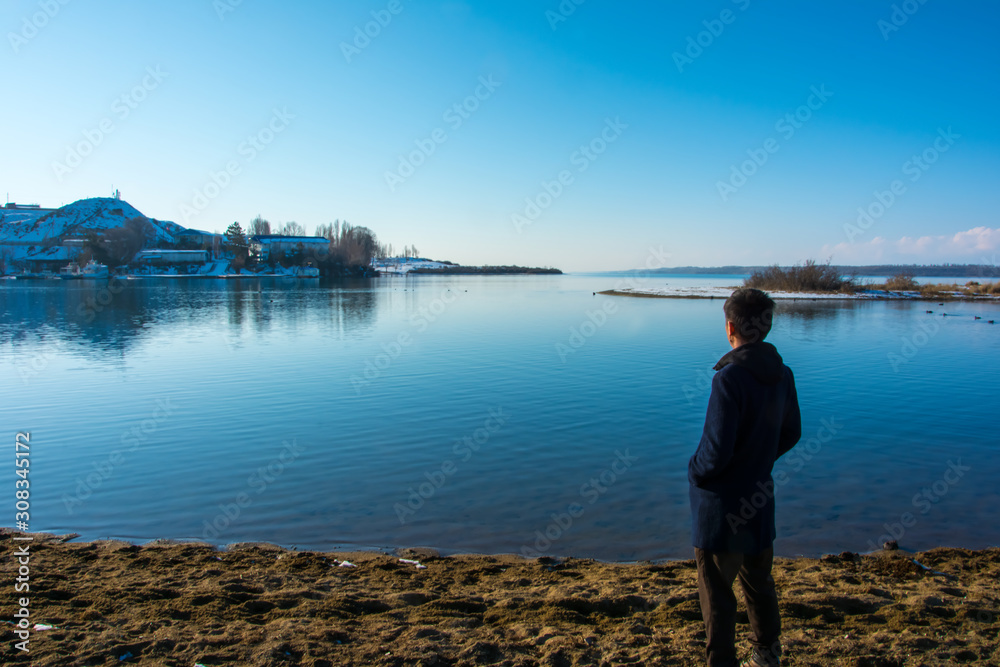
[688,288,802,667]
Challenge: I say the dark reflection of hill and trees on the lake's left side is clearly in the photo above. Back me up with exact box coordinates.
[0,279,385,358]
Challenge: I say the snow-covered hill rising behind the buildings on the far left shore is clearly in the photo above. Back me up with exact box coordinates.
[0,197,184,246]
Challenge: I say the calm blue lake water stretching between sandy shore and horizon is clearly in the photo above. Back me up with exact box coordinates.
[0,275,1000,560]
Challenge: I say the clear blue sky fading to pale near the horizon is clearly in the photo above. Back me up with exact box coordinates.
[0,0,1000,271]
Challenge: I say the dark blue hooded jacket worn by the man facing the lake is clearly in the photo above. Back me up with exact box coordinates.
[688,342,802,554]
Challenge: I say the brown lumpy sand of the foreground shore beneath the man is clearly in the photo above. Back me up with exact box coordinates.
[0,532,1000,667]
